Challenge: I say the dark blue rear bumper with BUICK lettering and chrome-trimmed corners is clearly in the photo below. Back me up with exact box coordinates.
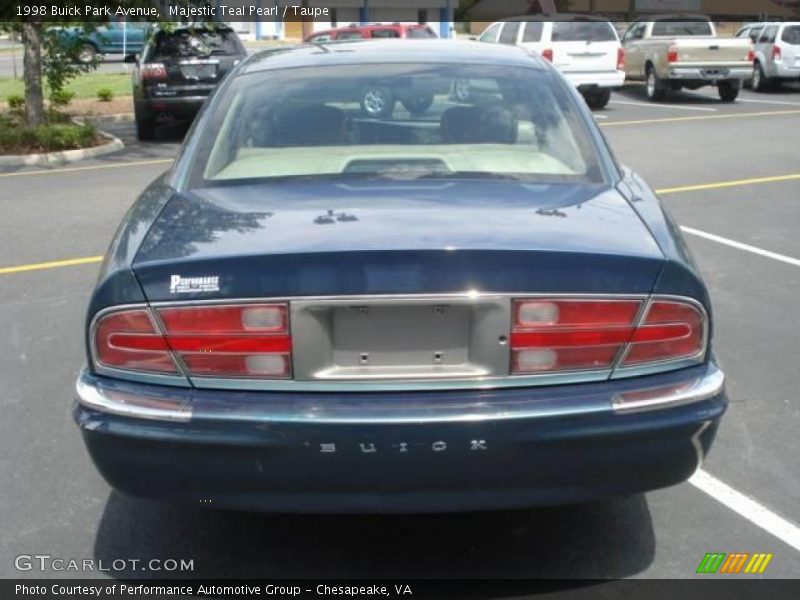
[74,363,727,512]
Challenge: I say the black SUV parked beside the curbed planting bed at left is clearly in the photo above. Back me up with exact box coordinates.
[130,24,247,140]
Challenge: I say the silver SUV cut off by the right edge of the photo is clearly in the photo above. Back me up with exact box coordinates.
[753,22,800,91]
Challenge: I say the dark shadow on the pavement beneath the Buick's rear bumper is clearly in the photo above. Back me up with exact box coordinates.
[94,492,655,586]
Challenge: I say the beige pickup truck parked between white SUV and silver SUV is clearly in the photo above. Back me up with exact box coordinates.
[622,15,753,102]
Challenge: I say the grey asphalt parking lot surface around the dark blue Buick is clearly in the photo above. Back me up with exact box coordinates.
[0,87,800,578]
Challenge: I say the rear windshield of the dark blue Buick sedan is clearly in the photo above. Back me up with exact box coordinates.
[191,64,606,187]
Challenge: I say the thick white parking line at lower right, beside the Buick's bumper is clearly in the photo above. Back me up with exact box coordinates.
[689,469,800,551]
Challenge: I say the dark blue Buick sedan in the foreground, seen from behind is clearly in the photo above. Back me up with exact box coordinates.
[74,41,726,512]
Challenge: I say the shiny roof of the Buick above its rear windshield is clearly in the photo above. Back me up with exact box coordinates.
[240,39,546,73]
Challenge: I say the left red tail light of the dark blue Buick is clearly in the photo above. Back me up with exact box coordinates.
[94,304,292,379]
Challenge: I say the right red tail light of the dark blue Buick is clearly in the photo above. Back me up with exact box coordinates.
[510,299,707,375]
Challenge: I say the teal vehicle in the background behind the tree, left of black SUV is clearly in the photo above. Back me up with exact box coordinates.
[60,21,152,63]
